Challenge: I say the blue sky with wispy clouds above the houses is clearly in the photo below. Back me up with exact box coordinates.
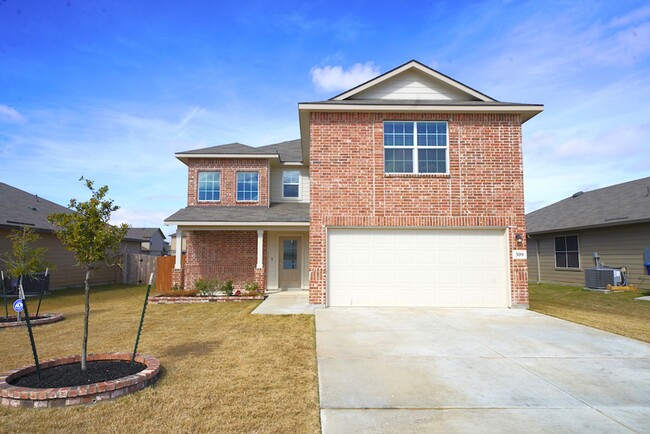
[0,0,650,233]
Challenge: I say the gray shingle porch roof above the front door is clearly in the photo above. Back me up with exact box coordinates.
[165,203,309,224]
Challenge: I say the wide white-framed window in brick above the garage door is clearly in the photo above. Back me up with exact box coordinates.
[384,121,449,174]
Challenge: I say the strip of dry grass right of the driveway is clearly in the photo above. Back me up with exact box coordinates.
[528,283,650,342]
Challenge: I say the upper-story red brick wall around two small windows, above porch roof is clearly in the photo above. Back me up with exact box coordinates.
[187,158,269,207]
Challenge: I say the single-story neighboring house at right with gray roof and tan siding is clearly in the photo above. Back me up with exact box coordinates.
[526,177,650,289]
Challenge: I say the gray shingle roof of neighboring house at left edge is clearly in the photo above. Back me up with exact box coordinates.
[0,182,72,231]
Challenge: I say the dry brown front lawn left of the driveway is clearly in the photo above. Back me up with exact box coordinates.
[0,286,318,433]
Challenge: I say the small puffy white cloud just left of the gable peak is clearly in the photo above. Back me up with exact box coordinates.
[310,62,379,92]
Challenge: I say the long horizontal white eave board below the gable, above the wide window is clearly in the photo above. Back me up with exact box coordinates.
[298,103,544,123]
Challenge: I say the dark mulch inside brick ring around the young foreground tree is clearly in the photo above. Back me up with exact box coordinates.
[8,360,146,388]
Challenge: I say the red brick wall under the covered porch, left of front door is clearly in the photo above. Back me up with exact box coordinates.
[184,230,267,291]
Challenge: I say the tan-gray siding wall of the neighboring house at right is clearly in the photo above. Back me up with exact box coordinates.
[528,223,650,289]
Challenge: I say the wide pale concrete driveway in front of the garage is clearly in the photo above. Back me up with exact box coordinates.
[316,308,650,433]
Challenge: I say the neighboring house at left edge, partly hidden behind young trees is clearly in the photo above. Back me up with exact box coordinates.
[0,183,139,288]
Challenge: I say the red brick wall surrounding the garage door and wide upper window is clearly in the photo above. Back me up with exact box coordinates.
[309,113,528,305]
